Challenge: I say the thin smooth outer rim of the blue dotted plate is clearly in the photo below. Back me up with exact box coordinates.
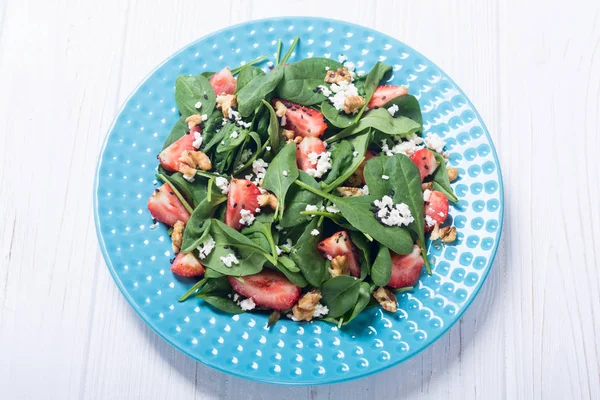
[93,15,504,386]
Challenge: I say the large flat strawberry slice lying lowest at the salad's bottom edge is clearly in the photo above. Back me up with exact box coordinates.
[227,269,301,311]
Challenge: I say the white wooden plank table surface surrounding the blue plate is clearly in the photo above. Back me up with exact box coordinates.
[0,0,600,400]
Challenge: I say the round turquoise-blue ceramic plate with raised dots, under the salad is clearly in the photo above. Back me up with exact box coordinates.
[94,17,503,385]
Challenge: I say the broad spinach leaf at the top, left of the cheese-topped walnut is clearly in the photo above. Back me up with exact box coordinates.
[277,58,342,106]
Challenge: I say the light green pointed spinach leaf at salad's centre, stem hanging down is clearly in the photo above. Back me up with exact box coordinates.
[262,142,298,216]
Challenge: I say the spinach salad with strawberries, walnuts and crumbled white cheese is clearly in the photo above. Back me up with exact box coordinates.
[148,38,458,326]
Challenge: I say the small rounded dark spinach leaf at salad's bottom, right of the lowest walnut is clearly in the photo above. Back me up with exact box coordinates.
[321,276,361,318]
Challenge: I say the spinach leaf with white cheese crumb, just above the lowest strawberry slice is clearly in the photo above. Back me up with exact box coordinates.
[203,219,276,276]
